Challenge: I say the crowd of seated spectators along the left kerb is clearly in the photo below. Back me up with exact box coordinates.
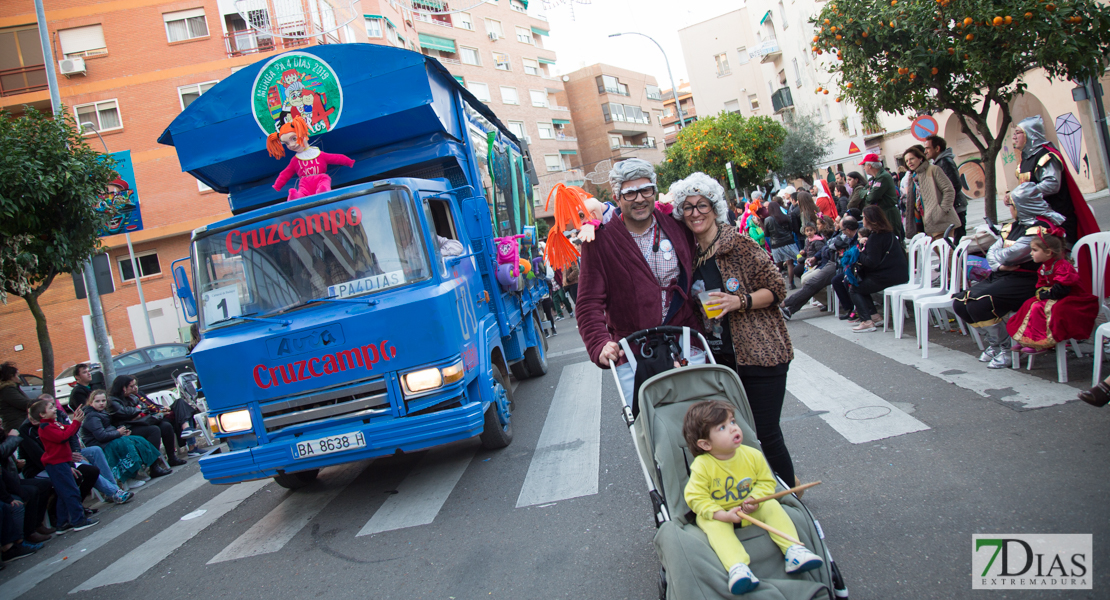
[0,362,201,568]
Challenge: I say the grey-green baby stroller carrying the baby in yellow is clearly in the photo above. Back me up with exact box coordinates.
[611,326,848,600]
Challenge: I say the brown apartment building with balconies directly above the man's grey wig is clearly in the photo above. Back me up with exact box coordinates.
[563,63,663,195]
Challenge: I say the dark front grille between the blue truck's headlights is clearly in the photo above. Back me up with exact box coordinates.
[260,377,390,433]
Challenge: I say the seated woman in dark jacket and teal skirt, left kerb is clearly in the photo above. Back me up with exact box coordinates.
[81,389,170,487]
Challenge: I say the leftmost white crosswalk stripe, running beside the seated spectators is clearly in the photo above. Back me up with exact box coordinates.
[0,472,205,600]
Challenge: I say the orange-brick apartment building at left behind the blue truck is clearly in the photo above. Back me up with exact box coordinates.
[0,0,404,373]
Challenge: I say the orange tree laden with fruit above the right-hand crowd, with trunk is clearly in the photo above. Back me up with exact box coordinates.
[810,0,1110,220]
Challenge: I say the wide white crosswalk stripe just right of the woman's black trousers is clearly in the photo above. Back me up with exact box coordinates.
[786,348,929,444]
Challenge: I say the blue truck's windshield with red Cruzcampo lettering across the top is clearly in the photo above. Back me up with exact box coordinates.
[196,189,431,328]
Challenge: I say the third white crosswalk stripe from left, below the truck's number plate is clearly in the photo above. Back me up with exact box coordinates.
[208,460,370,565]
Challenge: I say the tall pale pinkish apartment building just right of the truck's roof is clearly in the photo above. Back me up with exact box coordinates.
[390,0,582,216]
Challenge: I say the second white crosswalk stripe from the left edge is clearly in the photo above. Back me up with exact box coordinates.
[70,479,272,593]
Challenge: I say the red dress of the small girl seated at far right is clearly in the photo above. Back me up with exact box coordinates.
[1006,258,1099,349]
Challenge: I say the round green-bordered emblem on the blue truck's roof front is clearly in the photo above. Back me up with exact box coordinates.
[251,52,343,135]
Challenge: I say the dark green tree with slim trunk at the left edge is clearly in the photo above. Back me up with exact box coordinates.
[0,108,117,393]
